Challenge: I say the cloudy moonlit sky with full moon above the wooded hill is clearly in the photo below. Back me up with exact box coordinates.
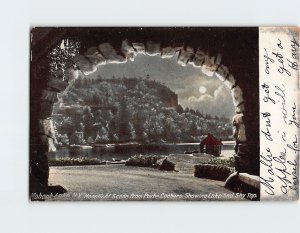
[85,54,234,118]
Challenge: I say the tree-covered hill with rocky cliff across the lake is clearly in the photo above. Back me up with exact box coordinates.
[53,77,232,145]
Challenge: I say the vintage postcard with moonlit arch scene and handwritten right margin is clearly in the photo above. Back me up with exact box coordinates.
[29,27,300,201]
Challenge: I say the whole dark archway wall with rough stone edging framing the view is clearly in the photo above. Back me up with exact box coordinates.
[30,28,259,193]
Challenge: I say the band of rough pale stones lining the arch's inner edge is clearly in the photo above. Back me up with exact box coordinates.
[30,27,259,197]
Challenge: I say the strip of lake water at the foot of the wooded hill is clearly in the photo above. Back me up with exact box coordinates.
[49,141,234,161]
